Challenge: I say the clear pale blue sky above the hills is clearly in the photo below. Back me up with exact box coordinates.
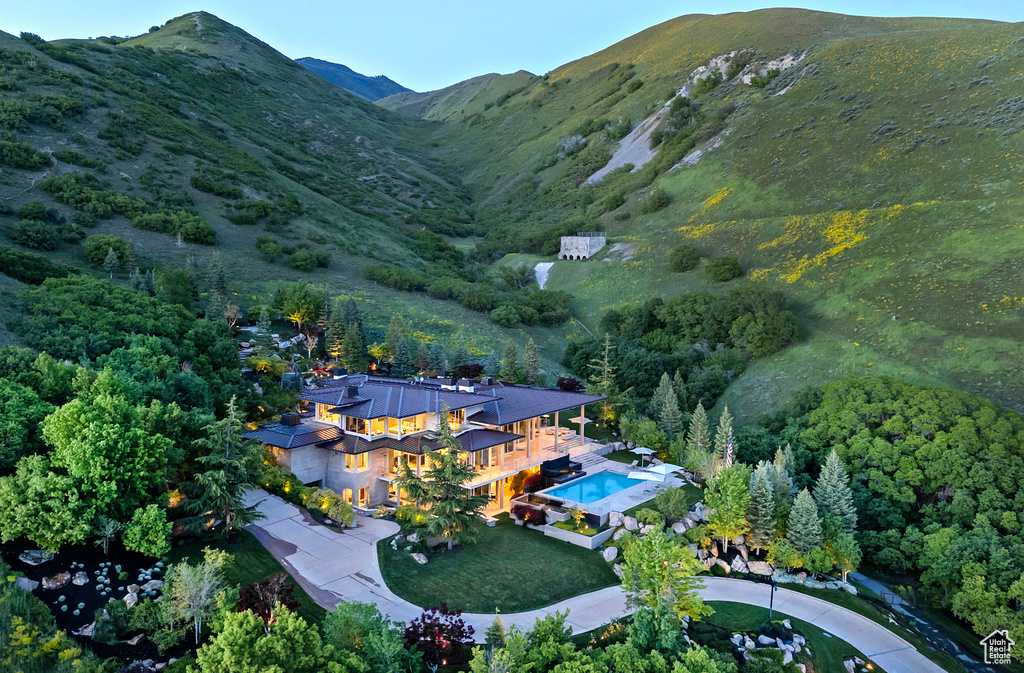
[0,0,1024,91]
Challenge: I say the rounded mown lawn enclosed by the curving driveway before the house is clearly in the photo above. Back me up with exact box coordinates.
[377,514,618,613]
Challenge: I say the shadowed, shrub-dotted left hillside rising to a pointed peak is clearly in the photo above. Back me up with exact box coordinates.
[0,12,558,372]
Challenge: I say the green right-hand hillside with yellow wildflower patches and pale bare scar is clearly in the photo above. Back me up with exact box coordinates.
[405,9,1024,418]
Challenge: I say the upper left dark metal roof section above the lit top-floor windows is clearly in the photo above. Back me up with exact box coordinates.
[299,375,494,420]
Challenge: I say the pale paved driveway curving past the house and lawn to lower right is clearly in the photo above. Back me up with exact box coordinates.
[248,491,942,673]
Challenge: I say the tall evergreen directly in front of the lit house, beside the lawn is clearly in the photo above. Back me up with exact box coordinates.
[424,405,487,549]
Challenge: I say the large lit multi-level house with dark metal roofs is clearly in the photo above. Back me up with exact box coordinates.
[245,370,604,509]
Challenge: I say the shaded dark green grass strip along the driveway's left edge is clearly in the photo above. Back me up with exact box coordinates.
[168,531,327,624]
